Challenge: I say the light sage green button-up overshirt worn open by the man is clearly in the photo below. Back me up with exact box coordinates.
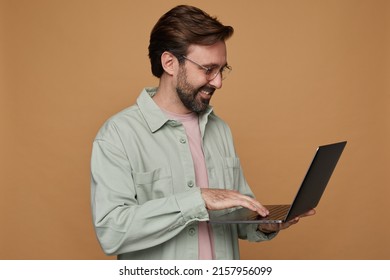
[91,88,274,260]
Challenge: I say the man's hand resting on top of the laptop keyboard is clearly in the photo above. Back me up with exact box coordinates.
[201,188,269,217]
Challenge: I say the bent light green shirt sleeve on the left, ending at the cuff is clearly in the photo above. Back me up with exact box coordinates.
[91,139,209,255]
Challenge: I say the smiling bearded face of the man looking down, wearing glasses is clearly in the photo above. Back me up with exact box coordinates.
[176,42,226,113]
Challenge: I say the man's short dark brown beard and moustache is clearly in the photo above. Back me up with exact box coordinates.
[176,67,215,114]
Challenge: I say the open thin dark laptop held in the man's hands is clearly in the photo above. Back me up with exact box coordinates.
[209,141,347,224]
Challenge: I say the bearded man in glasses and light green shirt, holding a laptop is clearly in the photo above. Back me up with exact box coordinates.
[91,5,314,259]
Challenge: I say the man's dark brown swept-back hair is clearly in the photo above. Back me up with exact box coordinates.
[149,5,234,78]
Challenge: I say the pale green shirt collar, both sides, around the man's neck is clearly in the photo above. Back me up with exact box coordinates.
[137,87,213,133]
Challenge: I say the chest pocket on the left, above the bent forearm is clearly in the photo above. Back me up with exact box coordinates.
[133,167,173,204]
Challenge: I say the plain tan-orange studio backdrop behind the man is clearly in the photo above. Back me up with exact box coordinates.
[0,0,390,259]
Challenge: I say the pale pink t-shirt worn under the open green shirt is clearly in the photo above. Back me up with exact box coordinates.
[164,111,214,260]
